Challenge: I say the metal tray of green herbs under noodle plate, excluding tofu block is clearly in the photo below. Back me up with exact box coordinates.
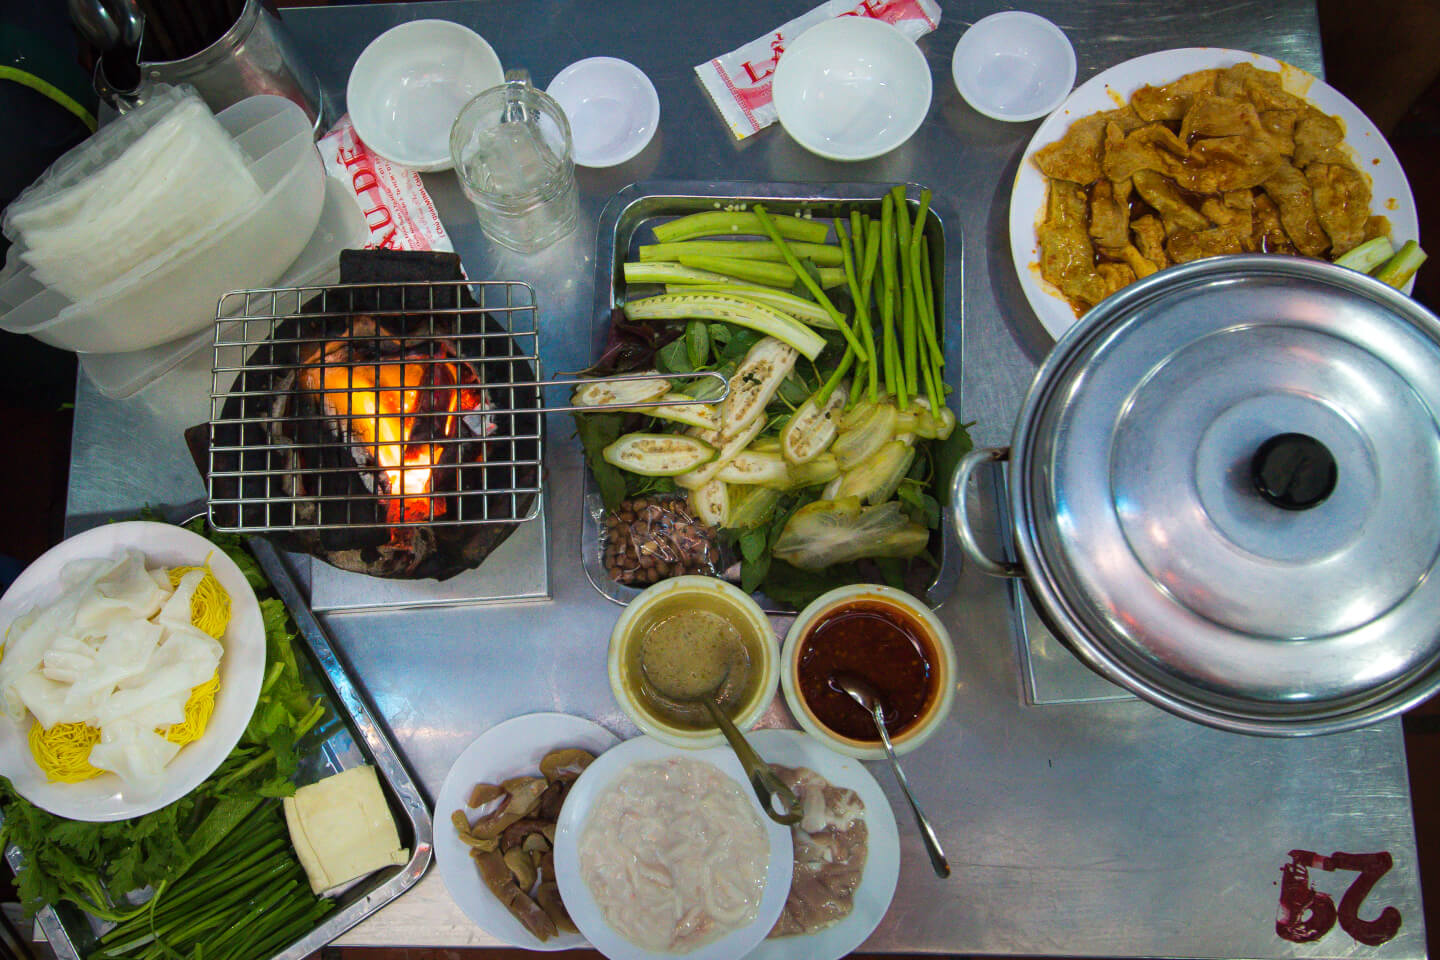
[0,520,432,960]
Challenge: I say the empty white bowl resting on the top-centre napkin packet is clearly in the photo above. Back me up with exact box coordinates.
[770,17,932,160]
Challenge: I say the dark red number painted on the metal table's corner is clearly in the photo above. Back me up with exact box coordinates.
[1274,851,1400,947]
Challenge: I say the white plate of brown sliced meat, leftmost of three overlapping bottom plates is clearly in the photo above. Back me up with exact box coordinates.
[435,714,619,950]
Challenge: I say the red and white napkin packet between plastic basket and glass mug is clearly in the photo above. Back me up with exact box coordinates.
[315,114,455,253]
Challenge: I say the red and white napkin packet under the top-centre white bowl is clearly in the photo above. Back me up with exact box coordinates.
[696,0,940,140]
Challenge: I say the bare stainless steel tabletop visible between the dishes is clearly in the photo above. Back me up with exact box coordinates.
[59,0,1426,959]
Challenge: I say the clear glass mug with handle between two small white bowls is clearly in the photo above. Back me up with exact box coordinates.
[451,71,579,253]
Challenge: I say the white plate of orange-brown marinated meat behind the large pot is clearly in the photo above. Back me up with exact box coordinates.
[1009,47,1420,338]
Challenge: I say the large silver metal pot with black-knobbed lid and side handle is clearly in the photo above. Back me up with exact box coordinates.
[952,256,1440,735]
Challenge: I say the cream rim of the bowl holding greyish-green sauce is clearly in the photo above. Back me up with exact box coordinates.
[606,574,782,750]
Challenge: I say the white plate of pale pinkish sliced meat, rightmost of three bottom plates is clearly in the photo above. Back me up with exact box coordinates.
[746,730,898,960]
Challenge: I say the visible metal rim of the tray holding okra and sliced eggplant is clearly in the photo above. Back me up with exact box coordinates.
[580,180,965,615]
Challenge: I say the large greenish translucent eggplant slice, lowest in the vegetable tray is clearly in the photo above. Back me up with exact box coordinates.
[772,497,930,570]
